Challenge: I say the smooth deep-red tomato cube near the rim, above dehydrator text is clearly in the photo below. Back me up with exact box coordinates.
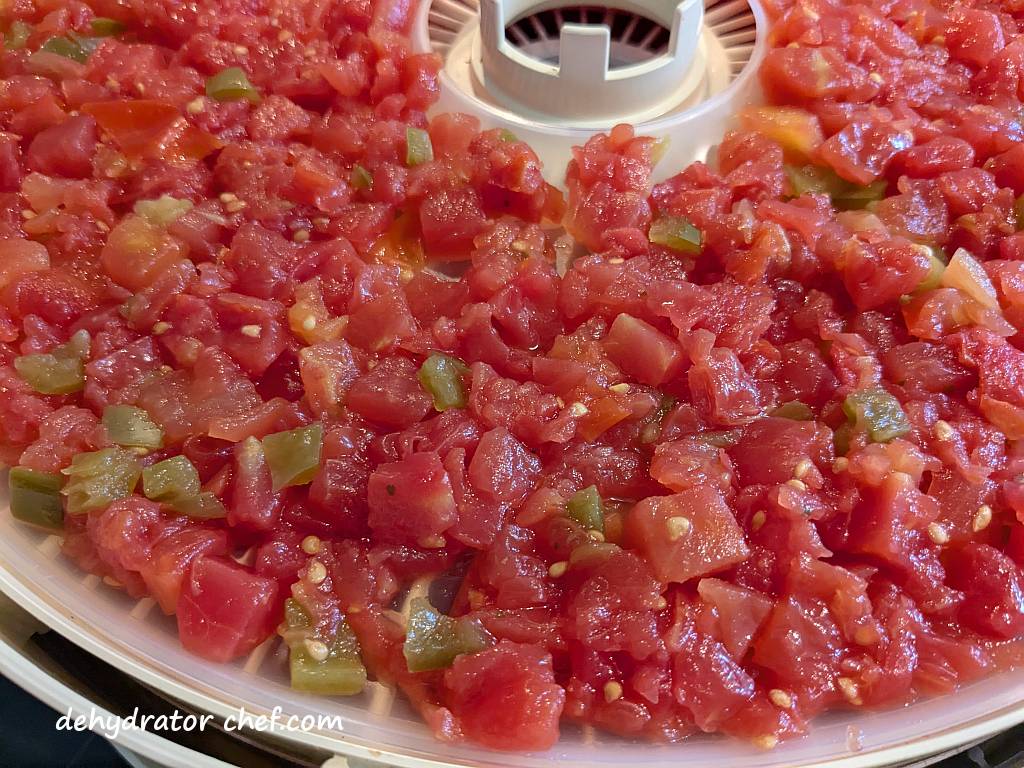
[175,555,284,663]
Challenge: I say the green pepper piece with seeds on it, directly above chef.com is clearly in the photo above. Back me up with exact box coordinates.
[285,598,367,696]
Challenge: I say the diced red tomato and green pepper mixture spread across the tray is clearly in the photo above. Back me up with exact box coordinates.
[0,0,1024,750]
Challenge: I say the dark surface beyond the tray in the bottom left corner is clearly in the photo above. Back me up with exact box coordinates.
[0,677,127,768]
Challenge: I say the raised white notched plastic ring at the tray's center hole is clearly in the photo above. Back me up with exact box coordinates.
[473,0,703,127]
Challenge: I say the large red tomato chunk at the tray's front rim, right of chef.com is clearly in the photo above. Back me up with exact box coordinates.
[444,640,565,752]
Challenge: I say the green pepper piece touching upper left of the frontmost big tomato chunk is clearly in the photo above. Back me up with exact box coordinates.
[402,597,492,672]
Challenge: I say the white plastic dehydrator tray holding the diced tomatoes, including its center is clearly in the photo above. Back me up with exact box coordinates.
[0,0,1024,768]
